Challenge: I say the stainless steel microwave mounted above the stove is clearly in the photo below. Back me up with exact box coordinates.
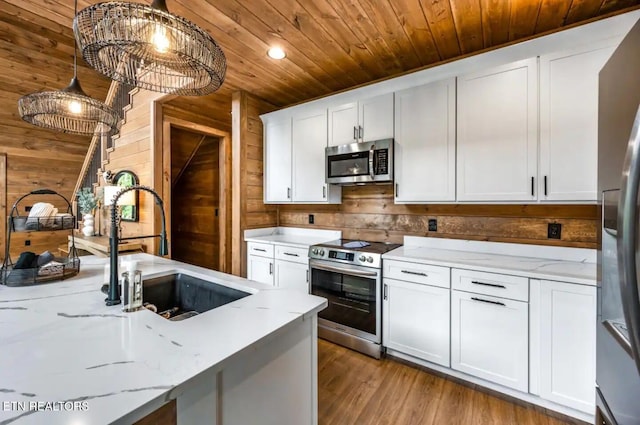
[325,139,393,185]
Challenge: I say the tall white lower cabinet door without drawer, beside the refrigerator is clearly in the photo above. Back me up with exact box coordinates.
[531,280,596,413]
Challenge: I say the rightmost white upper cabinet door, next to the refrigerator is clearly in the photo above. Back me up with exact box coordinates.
[538,41,615,201]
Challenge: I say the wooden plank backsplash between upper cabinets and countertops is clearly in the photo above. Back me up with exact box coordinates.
[278,185,598,248]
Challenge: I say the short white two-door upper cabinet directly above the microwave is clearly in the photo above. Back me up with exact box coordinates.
[328,93,393,146]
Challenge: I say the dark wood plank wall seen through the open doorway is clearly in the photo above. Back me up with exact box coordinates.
[171,128,220,270]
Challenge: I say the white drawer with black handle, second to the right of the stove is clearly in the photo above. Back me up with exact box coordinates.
[451,269,529,301]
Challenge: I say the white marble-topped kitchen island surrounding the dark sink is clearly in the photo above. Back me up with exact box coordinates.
[0,254,326,425]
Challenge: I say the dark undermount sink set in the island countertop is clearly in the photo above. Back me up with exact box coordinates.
[142,273,251,320]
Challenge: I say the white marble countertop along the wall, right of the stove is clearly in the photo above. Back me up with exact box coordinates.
[383,237,596,285]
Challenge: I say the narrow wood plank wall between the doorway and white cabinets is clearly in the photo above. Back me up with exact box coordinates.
[231,91,278,276]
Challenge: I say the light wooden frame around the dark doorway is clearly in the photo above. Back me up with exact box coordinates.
[154,114,231,273]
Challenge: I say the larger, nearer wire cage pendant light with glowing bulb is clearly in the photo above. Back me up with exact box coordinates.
[73,0,227,96]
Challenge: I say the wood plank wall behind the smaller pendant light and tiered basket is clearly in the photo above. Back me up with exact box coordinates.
[0,0,110,261]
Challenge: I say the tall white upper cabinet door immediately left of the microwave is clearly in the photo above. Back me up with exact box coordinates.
[292,109,327,202]
